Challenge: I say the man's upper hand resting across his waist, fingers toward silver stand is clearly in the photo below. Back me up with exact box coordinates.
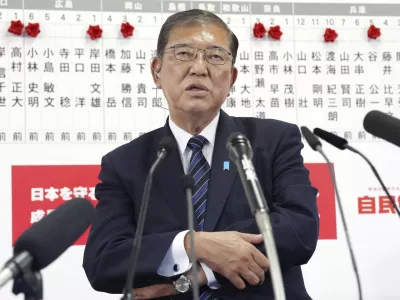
[185,231,269,289]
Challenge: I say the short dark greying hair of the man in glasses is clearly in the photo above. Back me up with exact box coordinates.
[157,9,239,65]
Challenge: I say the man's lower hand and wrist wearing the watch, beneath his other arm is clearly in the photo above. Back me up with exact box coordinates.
[133,265,208,300]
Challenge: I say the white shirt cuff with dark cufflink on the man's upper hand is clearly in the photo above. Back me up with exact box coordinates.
[157,230,192,277]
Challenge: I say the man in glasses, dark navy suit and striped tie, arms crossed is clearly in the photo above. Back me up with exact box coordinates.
[83,10,319,300]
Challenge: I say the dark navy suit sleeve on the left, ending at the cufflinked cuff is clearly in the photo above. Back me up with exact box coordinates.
[83,155,179,293]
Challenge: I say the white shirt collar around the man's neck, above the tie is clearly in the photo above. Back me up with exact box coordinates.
[168,112,220,154]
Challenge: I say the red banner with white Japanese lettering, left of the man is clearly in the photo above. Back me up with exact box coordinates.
[12,165,100,245]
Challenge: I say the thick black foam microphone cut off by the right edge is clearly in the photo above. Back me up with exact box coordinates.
[364,110,400,147]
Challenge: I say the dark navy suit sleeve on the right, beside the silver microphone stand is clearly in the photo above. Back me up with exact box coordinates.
[212,125,319,283]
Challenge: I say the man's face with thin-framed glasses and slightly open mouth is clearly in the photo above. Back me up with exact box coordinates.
[152,25,237,114]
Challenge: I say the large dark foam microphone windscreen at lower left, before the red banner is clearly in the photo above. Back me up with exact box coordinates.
[14,198,94,271]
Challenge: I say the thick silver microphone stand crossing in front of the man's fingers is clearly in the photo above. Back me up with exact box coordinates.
[236,155,286,300]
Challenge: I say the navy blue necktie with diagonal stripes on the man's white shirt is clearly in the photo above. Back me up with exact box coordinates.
[188,135,217,300]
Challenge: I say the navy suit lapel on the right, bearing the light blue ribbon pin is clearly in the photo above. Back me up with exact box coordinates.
[204,110,238,231]
